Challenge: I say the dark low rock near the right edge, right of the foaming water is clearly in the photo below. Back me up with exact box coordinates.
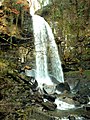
[73,95,89,104]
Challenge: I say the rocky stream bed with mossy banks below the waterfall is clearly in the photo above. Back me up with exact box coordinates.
[0,49,90,120]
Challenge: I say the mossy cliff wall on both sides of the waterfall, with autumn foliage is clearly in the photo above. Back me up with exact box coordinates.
[0,0,90,71]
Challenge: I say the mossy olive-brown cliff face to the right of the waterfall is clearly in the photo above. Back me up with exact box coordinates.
[37,0,90,70]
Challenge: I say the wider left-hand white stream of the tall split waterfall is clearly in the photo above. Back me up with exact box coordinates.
[32,15,52,85]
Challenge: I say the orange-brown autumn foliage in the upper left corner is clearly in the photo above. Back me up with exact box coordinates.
[0,0,29,37]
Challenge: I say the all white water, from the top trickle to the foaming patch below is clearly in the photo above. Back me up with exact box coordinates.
[26,0,83,112]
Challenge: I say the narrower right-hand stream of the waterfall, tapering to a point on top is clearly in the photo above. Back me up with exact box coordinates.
[45,21,64,82]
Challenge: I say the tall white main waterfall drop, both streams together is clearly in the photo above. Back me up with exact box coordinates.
[32,15,64,85]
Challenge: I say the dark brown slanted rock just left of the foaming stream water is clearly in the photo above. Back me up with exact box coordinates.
[42,101,57,111]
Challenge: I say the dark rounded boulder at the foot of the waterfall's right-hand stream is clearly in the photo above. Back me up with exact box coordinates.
[56,82,70,93]
